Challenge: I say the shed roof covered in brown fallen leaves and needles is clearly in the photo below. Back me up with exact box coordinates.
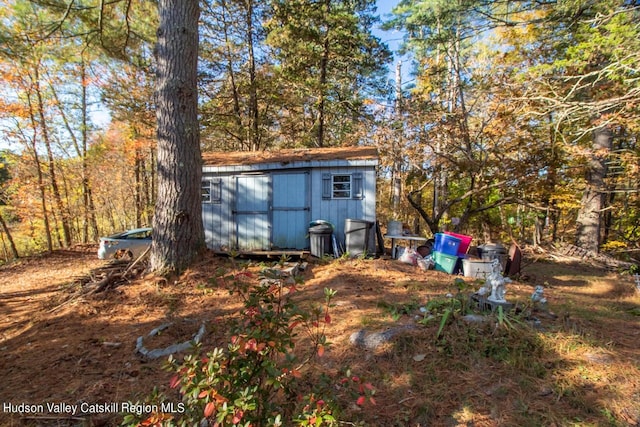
[202,147,378,169]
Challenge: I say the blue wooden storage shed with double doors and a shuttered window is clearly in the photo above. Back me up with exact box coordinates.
[202,147,378,252]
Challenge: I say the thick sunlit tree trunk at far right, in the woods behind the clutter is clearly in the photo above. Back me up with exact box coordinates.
[576,128,613,252]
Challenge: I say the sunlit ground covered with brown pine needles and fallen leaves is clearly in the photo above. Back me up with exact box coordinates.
[0,247,640,426]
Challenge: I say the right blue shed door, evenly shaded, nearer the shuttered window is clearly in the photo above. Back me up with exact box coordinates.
[272,172,310,249]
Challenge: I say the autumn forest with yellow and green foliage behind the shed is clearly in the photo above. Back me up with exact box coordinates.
[0,0,640,262]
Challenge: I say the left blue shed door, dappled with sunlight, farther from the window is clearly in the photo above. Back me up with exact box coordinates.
[235,175,271,250]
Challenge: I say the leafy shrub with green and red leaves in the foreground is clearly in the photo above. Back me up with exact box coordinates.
[124,271,374,427]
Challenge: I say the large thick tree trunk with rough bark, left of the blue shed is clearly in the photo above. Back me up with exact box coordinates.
[151,0,204,274]
